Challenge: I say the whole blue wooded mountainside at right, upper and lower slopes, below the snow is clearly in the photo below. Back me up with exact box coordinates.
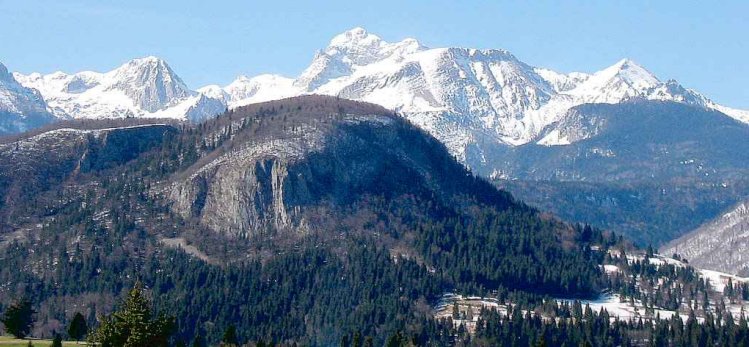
[485,100,749,245]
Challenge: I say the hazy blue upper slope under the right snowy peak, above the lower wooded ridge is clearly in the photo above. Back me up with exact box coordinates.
[492,101,749,182]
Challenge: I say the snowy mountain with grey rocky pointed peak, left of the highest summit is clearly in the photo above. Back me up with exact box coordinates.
[14,57,225,120]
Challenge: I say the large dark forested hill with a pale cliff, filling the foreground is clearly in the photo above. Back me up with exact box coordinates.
[0,96,736,345]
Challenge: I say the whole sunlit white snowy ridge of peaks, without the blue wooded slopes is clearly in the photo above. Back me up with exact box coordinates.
[7,28,749,166]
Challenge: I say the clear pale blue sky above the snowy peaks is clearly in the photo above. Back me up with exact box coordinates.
[0,0,749,109]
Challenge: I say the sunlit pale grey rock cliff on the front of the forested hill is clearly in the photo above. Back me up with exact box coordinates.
[170,139,316,237]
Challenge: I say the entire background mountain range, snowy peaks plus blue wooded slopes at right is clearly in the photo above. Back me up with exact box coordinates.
[0,28,749,244]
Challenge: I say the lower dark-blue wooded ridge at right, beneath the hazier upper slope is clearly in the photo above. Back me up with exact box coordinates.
[492,178,749,246]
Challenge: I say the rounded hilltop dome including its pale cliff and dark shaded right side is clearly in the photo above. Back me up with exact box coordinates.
[165,96,504,238]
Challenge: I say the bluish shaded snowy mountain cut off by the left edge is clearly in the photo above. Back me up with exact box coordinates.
[0,63,53,134]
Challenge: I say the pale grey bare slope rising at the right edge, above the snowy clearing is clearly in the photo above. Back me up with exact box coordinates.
[661,200,749,275]
